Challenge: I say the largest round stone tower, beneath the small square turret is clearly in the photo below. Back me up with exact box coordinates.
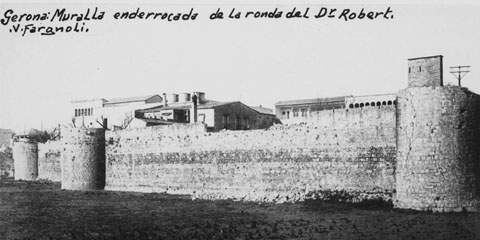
[395,86,480,211]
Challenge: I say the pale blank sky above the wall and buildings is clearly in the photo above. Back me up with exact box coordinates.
[0,0,480,131]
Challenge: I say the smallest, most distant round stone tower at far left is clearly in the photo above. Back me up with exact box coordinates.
[13,142,38,180]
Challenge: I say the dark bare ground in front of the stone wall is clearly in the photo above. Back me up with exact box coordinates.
[0,179,480,239]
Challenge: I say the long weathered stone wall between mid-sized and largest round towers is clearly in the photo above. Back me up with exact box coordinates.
[106,106,396,202]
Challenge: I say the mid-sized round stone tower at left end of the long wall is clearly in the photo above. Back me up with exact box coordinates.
[61,128,105,190]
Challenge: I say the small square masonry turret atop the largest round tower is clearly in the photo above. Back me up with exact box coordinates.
[408,55,443,88]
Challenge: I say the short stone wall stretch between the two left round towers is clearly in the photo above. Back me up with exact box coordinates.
[38,141,63,182]
